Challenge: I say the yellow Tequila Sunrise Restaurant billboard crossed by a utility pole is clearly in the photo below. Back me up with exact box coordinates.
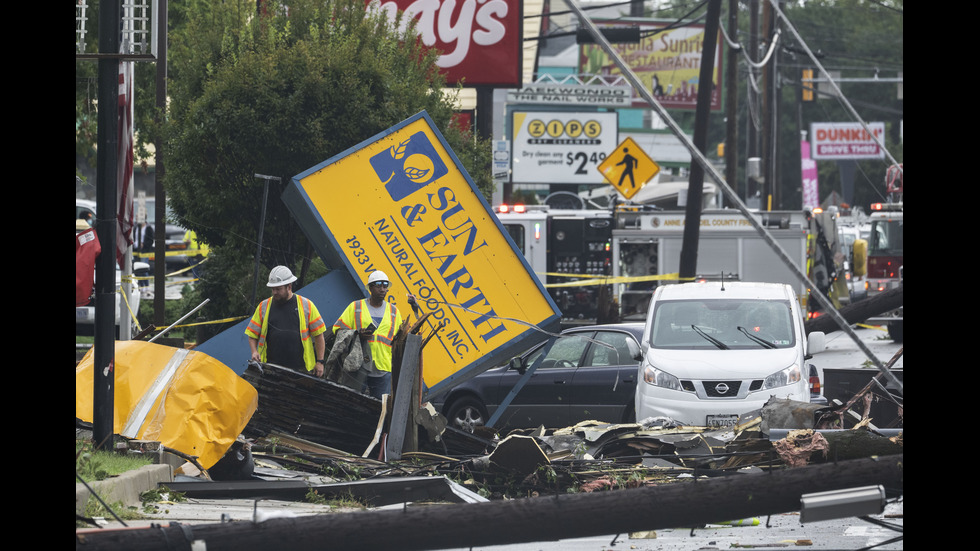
[579,21,723,111]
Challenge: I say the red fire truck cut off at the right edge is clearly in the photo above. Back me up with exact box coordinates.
[867,165,905,342]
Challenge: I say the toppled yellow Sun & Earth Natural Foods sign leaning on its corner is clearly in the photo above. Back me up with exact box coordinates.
[293,112,560,392]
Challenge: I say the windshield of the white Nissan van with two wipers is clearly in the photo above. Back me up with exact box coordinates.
[650,299,796,350]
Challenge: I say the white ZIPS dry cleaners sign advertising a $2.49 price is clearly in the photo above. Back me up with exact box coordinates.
[511,111,619,184]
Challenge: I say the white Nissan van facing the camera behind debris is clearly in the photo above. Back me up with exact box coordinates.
[636,282,823,427]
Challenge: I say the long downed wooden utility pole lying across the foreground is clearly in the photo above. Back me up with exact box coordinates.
[75,455,904,551]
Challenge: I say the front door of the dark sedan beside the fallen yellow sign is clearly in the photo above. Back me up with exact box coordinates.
[494,332,592,428]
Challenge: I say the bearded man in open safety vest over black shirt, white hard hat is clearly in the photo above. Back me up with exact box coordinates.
[245,266,327,377]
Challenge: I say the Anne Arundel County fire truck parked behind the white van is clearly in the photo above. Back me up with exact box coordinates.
[495,205,834,327]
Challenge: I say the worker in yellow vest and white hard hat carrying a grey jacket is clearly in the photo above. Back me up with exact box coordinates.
[333,270,416,399]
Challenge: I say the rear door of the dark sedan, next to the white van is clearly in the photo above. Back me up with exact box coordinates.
[566,331,639,425]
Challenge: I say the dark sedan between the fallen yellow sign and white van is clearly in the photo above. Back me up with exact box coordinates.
[435,323,643,431]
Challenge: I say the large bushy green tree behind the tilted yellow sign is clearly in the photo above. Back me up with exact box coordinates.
[165,0,492,340]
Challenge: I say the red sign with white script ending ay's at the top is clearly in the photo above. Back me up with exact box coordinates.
[368,0,522,87]
